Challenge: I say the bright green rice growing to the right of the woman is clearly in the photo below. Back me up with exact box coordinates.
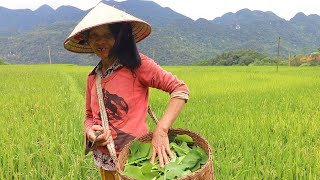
[151,67,320,179]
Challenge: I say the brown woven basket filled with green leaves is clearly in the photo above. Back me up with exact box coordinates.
[117,129,214,180]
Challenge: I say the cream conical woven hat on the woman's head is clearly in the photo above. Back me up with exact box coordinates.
[64,2,151,53]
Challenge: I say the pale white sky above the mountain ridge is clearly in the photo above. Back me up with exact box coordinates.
[0,0,320,20]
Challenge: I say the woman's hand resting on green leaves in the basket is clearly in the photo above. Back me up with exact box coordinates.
[150,123,174,168]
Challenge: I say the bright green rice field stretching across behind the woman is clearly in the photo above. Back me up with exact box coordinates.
[0,65,320,179]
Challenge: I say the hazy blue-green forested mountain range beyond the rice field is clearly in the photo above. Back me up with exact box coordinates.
[0,0,320,65]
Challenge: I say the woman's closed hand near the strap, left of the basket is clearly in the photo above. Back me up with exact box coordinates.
[87,125,111,148]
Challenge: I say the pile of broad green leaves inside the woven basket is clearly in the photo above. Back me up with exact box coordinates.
[123,134,208,180]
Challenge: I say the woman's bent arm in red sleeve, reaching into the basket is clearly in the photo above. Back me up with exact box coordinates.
[137,54,189,167]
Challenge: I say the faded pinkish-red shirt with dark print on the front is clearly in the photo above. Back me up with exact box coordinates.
[84,54,189,154]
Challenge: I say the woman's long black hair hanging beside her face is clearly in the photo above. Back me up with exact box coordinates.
[108,23,141,71]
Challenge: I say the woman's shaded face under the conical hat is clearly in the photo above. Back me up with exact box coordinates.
[88,25,115,59]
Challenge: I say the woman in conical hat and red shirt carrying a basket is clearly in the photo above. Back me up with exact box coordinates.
[64,3,189,179]
